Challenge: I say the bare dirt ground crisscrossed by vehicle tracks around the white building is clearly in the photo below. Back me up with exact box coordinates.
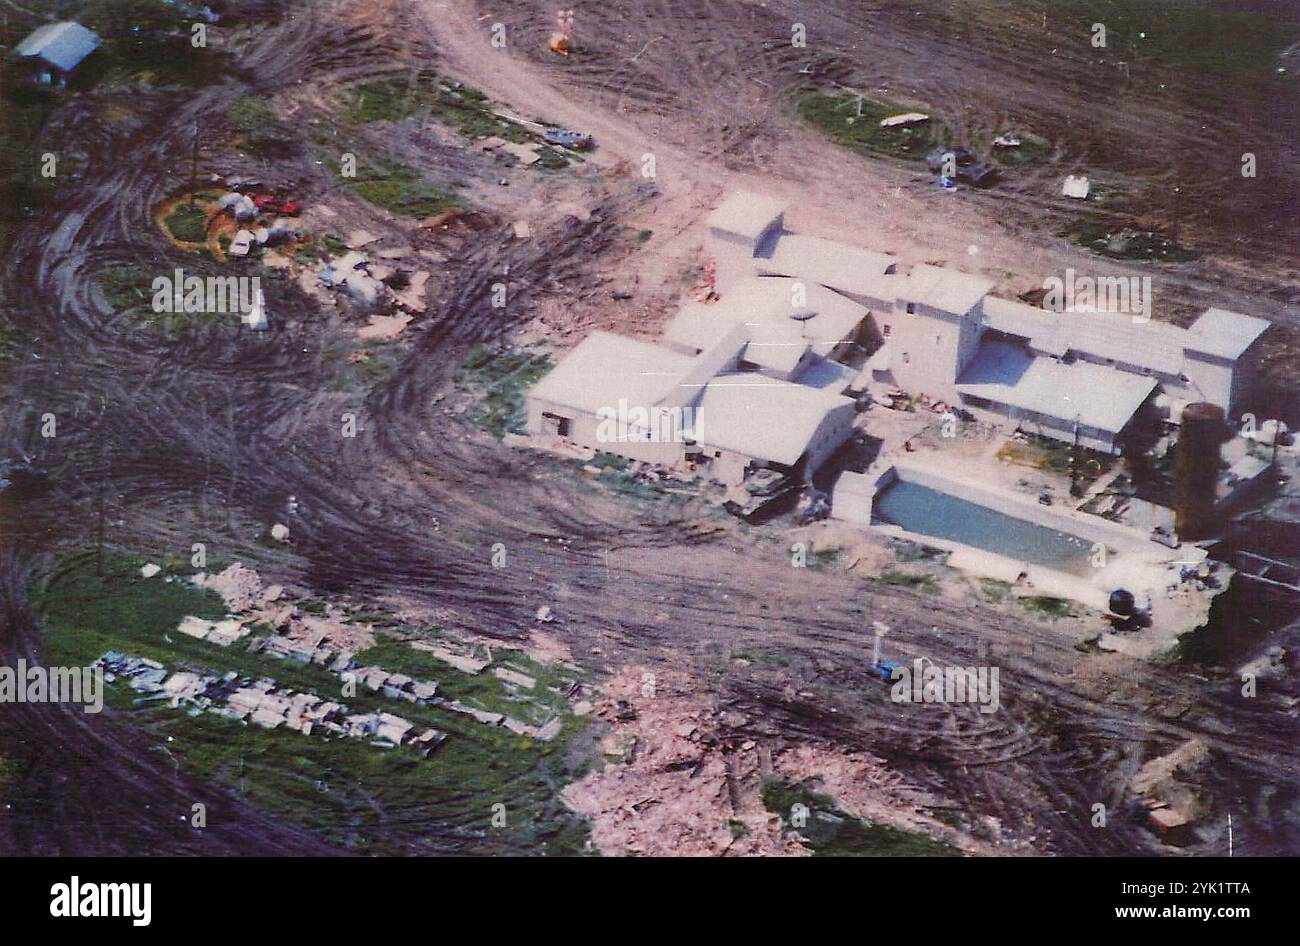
[0,0,1300,855]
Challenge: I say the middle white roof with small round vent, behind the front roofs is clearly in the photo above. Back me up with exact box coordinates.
[664,277,867,370]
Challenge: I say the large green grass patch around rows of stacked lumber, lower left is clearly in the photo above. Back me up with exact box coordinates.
[33,551,589,855]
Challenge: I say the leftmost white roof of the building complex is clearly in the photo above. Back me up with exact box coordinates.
[529,331,694,413]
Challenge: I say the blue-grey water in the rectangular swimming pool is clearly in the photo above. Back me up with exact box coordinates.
[872,479,1092,576]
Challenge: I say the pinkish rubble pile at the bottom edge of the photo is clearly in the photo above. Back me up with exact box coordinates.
[560,667,998,856]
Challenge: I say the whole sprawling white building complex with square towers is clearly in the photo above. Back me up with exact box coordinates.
[528,192,1268,485]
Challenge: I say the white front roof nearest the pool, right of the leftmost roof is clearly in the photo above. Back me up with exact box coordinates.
[693,373,853,465]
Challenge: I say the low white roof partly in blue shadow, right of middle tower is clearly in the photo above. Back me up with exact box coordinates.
[957,339,1156,433]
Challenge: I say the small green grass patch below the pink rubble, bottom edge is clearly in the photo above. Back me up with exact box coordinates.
[761,778,961,858]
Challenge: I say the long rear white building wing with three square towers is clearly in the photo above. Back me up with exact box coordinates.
[709,194,1269,451]
